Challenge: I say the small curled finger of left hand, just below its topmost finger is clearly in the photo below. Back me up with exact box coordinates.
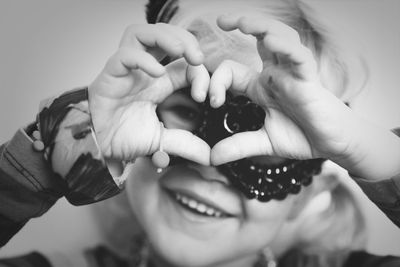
[105,47,165,77]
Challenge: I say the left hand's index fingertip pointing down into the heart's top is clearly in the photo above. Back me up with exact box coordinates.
[186,65,210,102]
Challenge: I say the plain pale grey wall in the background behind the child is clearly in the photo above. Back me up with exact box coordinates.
[0,0,400,256]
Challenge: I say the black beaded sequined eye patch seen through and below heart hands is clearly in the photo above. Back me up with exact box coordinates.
[166,91,324,202]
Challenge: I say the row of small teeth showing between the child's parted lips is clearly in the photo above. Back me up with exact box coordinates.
[168,190,232,219]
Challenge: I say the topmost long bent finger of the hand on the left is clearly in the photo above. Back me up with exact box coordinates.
[121,23,204,65]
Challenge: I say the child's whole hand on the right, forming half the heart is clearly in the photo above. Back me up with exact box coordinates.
[210,15,355,165]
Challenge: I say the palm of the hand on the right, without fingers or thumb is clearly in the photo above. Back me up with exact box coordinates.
[256,76,347,159]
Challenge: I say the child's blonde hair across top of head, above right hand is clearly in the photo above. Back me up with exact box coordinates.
[166,0,361,102]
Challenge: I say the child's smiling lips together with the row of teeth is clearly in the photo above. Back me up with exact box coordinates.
[160,165,243,218]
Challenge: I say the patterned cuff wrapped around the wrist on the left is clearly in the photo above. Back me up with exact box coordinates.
[37,89,122,205]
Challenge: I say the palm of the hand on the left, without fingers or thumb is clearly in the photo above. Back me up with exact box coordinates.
[91,71,164,159]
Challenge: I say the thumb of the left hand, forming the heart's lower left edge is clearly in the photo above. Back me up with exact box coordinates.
[163,129,210,165]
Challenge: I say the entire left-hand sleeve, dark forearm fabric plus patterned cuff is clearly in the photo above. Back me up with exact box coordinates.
[0,88,124,246]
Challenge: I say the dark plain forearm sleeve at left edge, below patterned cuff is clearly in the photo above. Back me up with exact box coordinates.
[0,129,62,246]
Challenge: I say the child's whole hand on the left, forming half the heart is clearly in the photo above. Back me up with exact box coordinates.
[89,24,210,165]
